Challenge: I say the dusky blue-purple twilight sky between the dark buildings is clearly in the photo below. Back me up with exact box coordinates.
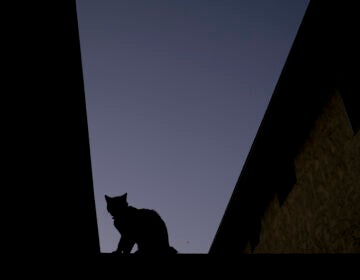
[77,0,309,253]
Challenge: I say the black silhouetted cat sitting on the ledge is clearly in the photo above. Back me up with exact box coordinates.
[105,193,177,255]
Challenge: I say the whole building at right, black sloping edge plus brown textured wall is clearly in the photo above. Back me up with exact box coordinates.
[209,1,360,254]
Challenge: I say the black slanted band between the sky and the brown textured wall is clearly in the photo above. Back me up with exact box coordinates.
[210,0,360,254]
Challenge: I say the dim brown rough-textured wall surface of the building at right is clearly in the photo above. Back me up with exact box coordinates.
[254,93,360,253]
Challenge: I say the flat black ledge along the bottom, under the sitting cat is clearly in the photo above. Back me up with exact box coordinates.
[9,252,360,280]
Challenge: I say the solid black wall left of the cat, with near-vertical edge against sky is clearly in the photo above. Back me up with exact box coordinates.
[3,1,100,256]
